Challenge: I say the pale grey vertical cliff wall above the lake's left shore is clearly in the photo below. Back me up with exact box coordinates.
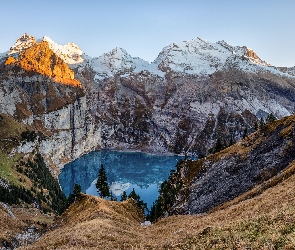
[18,96,101,174]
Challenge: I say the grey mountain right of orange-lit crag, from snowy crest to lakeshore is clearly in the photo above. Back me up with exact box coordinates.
[72,38,295,154]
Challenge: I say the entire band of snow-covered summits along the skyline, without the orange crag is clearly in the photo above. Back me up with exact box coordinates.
[2,33,294,80]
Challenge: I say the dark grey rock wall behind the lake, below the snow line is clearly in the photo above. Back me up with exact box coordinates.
[77,69,295,155]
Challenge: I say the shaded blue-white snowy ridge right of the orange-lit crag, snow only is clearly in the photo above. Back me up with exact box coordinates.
[90,37,293,80]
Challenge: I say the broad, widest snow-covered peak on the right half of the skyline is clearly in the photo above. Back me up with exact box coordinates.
[153,38,282,76]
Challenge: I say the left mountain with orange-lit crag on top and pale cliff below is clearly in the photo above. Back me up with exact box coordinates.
[0,36,100,174]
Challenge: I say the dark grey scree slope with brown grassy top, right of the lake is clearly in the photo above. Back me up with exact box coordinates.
[170,115,295,214]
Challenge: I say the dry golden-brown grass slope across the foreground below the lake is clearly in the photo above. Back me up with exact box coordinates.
[22,166,295,249]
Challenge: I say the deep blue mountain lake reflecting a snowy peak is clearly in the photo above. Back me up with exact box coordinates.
[59,150,183,208]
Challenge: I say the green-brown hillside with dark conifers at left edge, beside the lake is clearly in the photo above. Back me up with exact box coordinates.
[0,114,66,248]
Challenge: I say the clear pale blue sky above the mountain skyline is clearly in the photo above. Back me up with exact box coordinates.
[0,0,295,66]
